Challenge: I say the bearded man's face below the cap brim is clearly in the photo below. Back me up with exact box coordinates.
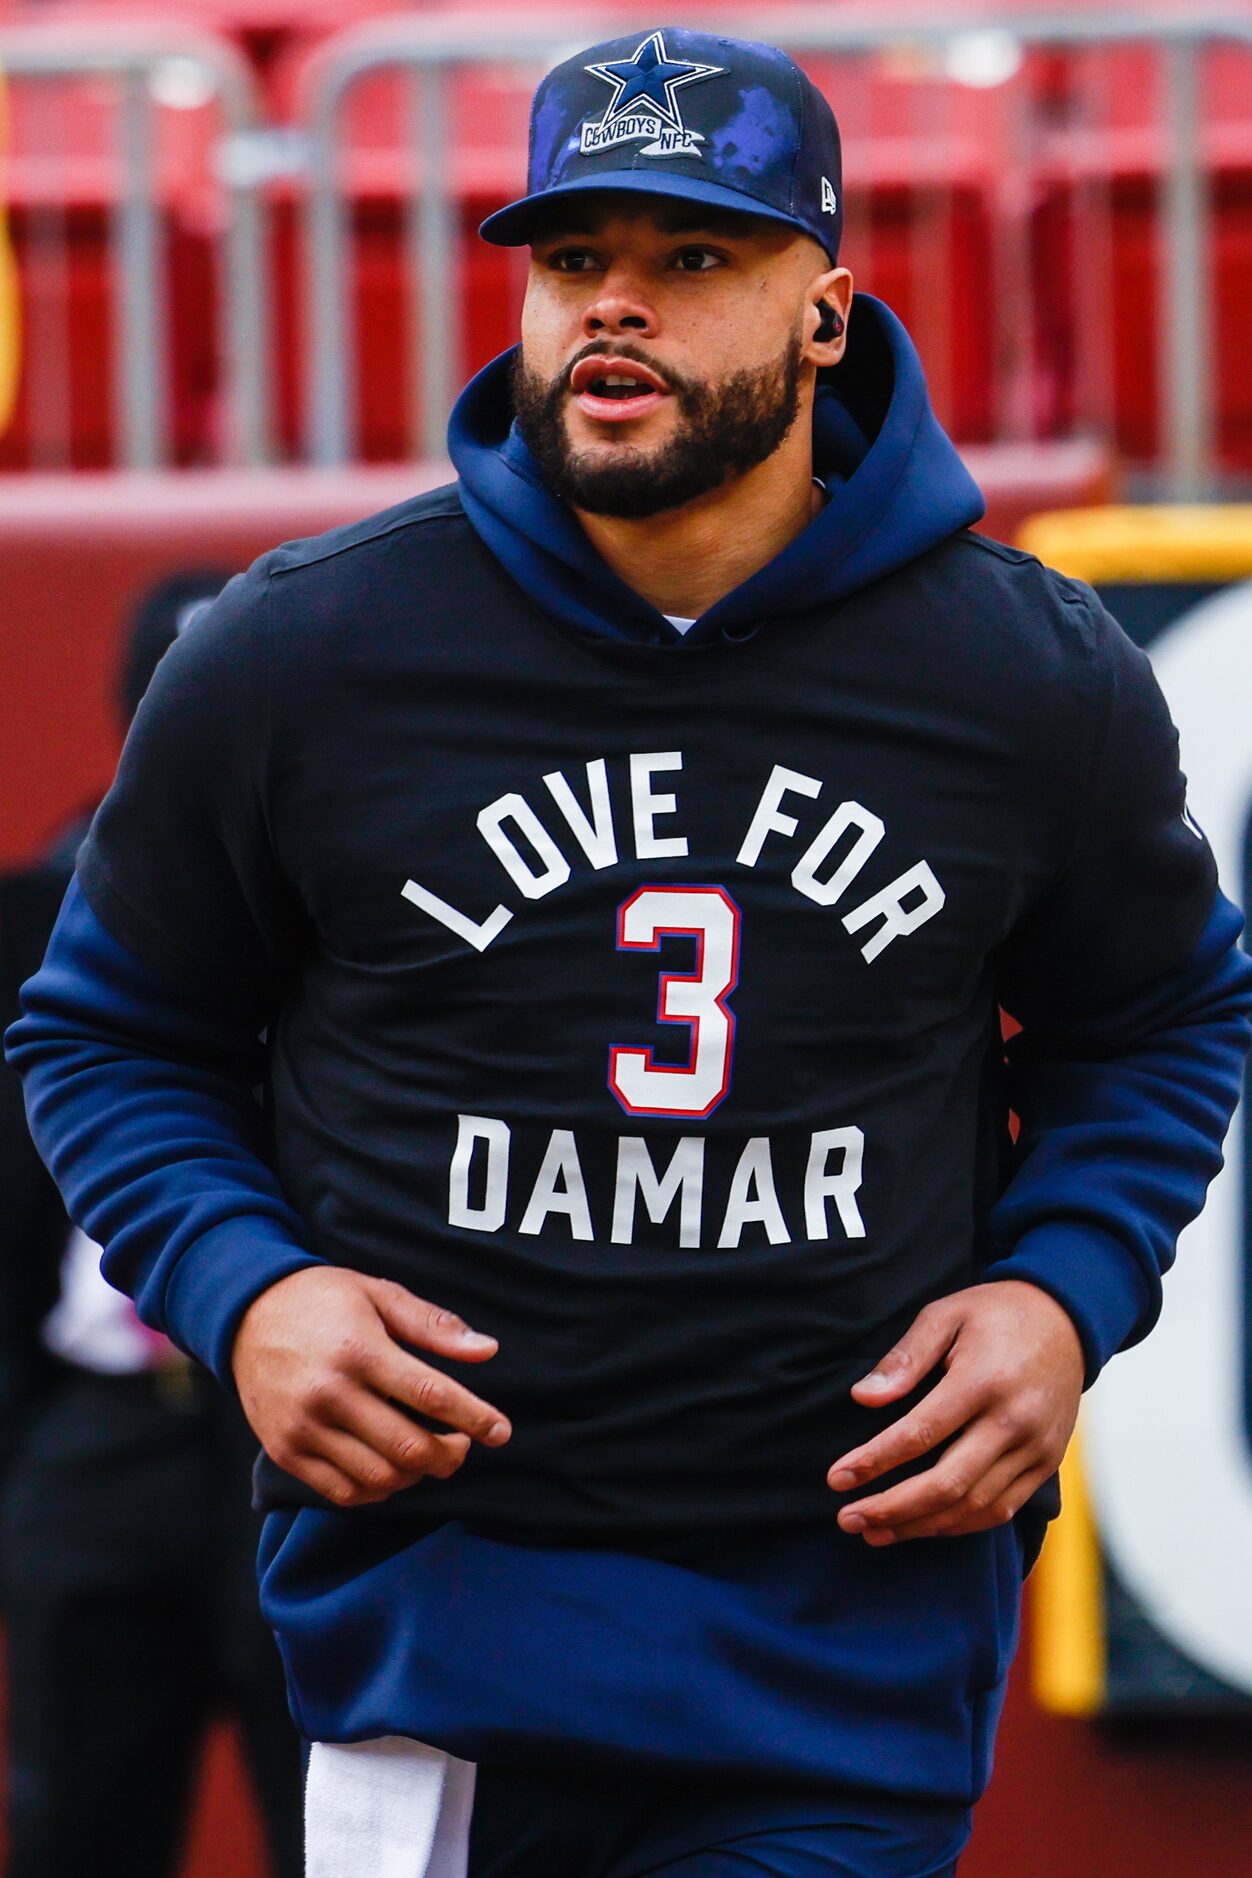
[514,192,828,516]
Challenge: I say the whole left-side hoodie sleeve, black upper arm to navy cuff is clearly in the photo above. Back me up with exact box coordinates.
[8,562,326,1382]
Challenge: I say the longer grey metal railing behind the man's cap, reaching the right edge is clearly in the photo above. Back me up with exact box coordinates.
[294,6,1252,498]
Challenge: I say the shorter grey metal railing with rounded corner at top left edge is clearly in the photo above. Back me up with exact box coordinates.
[0,23,270,470]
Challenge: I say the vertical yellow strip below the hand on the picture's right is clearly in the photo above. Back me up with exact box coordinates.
[1031,1435,1104,1715]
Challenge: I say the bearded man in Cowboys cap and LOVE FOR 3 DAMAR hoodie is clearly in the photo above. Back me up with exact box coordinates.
[11,28,1252,1878]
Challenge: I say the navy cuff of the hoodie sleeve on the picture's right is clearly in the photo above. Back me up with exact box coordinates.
[980,1221,1154,1388]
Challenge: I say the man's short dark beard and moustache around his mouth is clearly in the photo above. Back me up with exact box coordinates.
[512,332,803,520]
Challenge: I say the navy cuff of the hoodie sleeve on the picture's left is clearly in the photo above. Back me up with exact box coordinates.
[163,1219,327,1390]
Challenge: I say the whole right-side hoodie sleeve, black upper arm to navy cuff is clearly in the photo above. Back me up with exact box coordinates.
[984,584,1252,1382]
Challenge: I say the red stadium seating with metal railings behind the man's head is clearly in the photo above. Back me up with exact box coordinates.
[0,0,1252,498]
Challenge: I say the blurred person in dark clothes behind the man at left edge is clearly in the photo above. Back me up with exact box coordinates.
[0,571,302,1878]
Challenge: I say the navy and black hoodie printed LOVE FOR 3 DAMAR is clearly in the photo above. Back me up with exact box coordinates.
[9,297,1252,1803]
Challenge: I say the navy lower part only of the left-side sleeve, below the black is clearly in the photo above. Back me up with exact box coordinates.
[6,879,319,1386]
